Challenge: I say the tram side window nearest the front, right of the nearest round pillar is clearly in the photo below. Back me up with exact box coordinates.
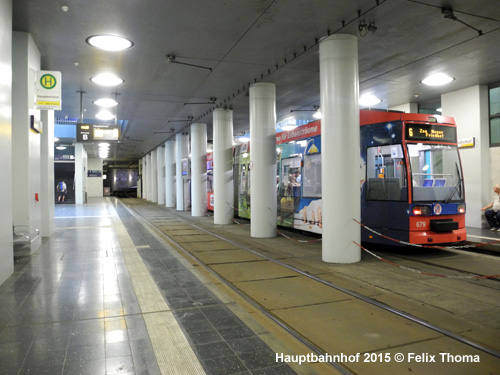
[366,145,408,201]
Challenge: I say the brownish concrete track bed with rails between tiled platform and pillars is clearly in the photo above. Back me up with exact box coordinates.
[121,199,500,374]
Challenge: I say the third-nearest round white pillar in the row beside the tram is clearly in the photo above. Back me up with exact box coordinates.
[213,108,234,225]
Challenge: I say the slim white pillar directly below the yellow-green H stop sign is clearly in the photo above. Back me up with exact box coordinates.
[40,111,56,237]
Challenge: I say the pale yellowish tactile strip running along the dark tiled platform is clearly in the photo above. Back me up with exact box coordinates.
[110,205,205,375]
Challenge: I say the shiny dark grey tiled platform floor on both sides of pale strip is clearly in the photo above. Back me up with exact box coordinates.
[0,200,295,375]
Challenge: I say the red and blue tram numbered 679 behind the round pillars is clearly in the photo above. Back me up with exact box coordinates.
[234,110,466,245]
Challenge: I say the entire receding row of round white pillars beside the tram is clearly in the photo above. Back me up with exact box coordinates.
[142,35,361,263]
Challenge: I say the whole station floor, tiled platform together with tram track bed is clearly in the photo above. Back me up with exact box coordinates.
[0,198,500,375]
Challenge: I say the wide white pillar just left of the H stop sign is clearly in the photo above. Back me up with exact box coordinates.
[12,32,42,252]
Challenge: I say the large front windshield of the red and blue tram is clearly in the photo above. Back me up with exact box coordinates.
[407,143,464,202]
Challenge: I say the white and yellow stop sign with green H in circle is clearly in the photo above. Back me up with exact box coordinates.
[35,70,62,111]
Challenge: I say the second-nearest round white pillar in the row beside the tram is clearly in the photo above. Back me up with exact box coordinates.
[249,82,277,238]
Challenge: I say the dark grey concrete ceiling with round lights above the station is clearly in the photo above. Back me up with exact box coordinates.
[13,0,500,163]
